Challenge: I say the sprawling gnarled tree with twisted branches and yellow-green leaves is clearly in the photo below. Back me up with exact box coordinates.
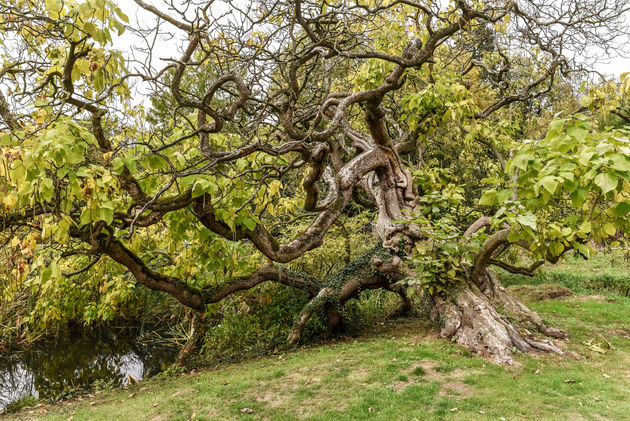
[0,0,630,362]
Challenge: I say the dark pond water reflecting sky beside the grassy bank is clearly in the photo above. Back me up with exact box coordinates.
[0,329,177,413]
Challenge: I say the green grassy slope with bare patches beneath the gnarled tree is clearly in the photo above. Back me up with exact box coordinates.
[7,260,630,421]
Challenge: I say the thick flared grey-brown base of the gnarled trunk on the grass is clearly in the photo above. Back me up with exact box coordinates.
[431,271,566,364]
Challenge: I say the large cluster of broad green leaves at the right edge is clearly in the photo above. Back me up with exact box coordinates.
[480,110,630,258]
